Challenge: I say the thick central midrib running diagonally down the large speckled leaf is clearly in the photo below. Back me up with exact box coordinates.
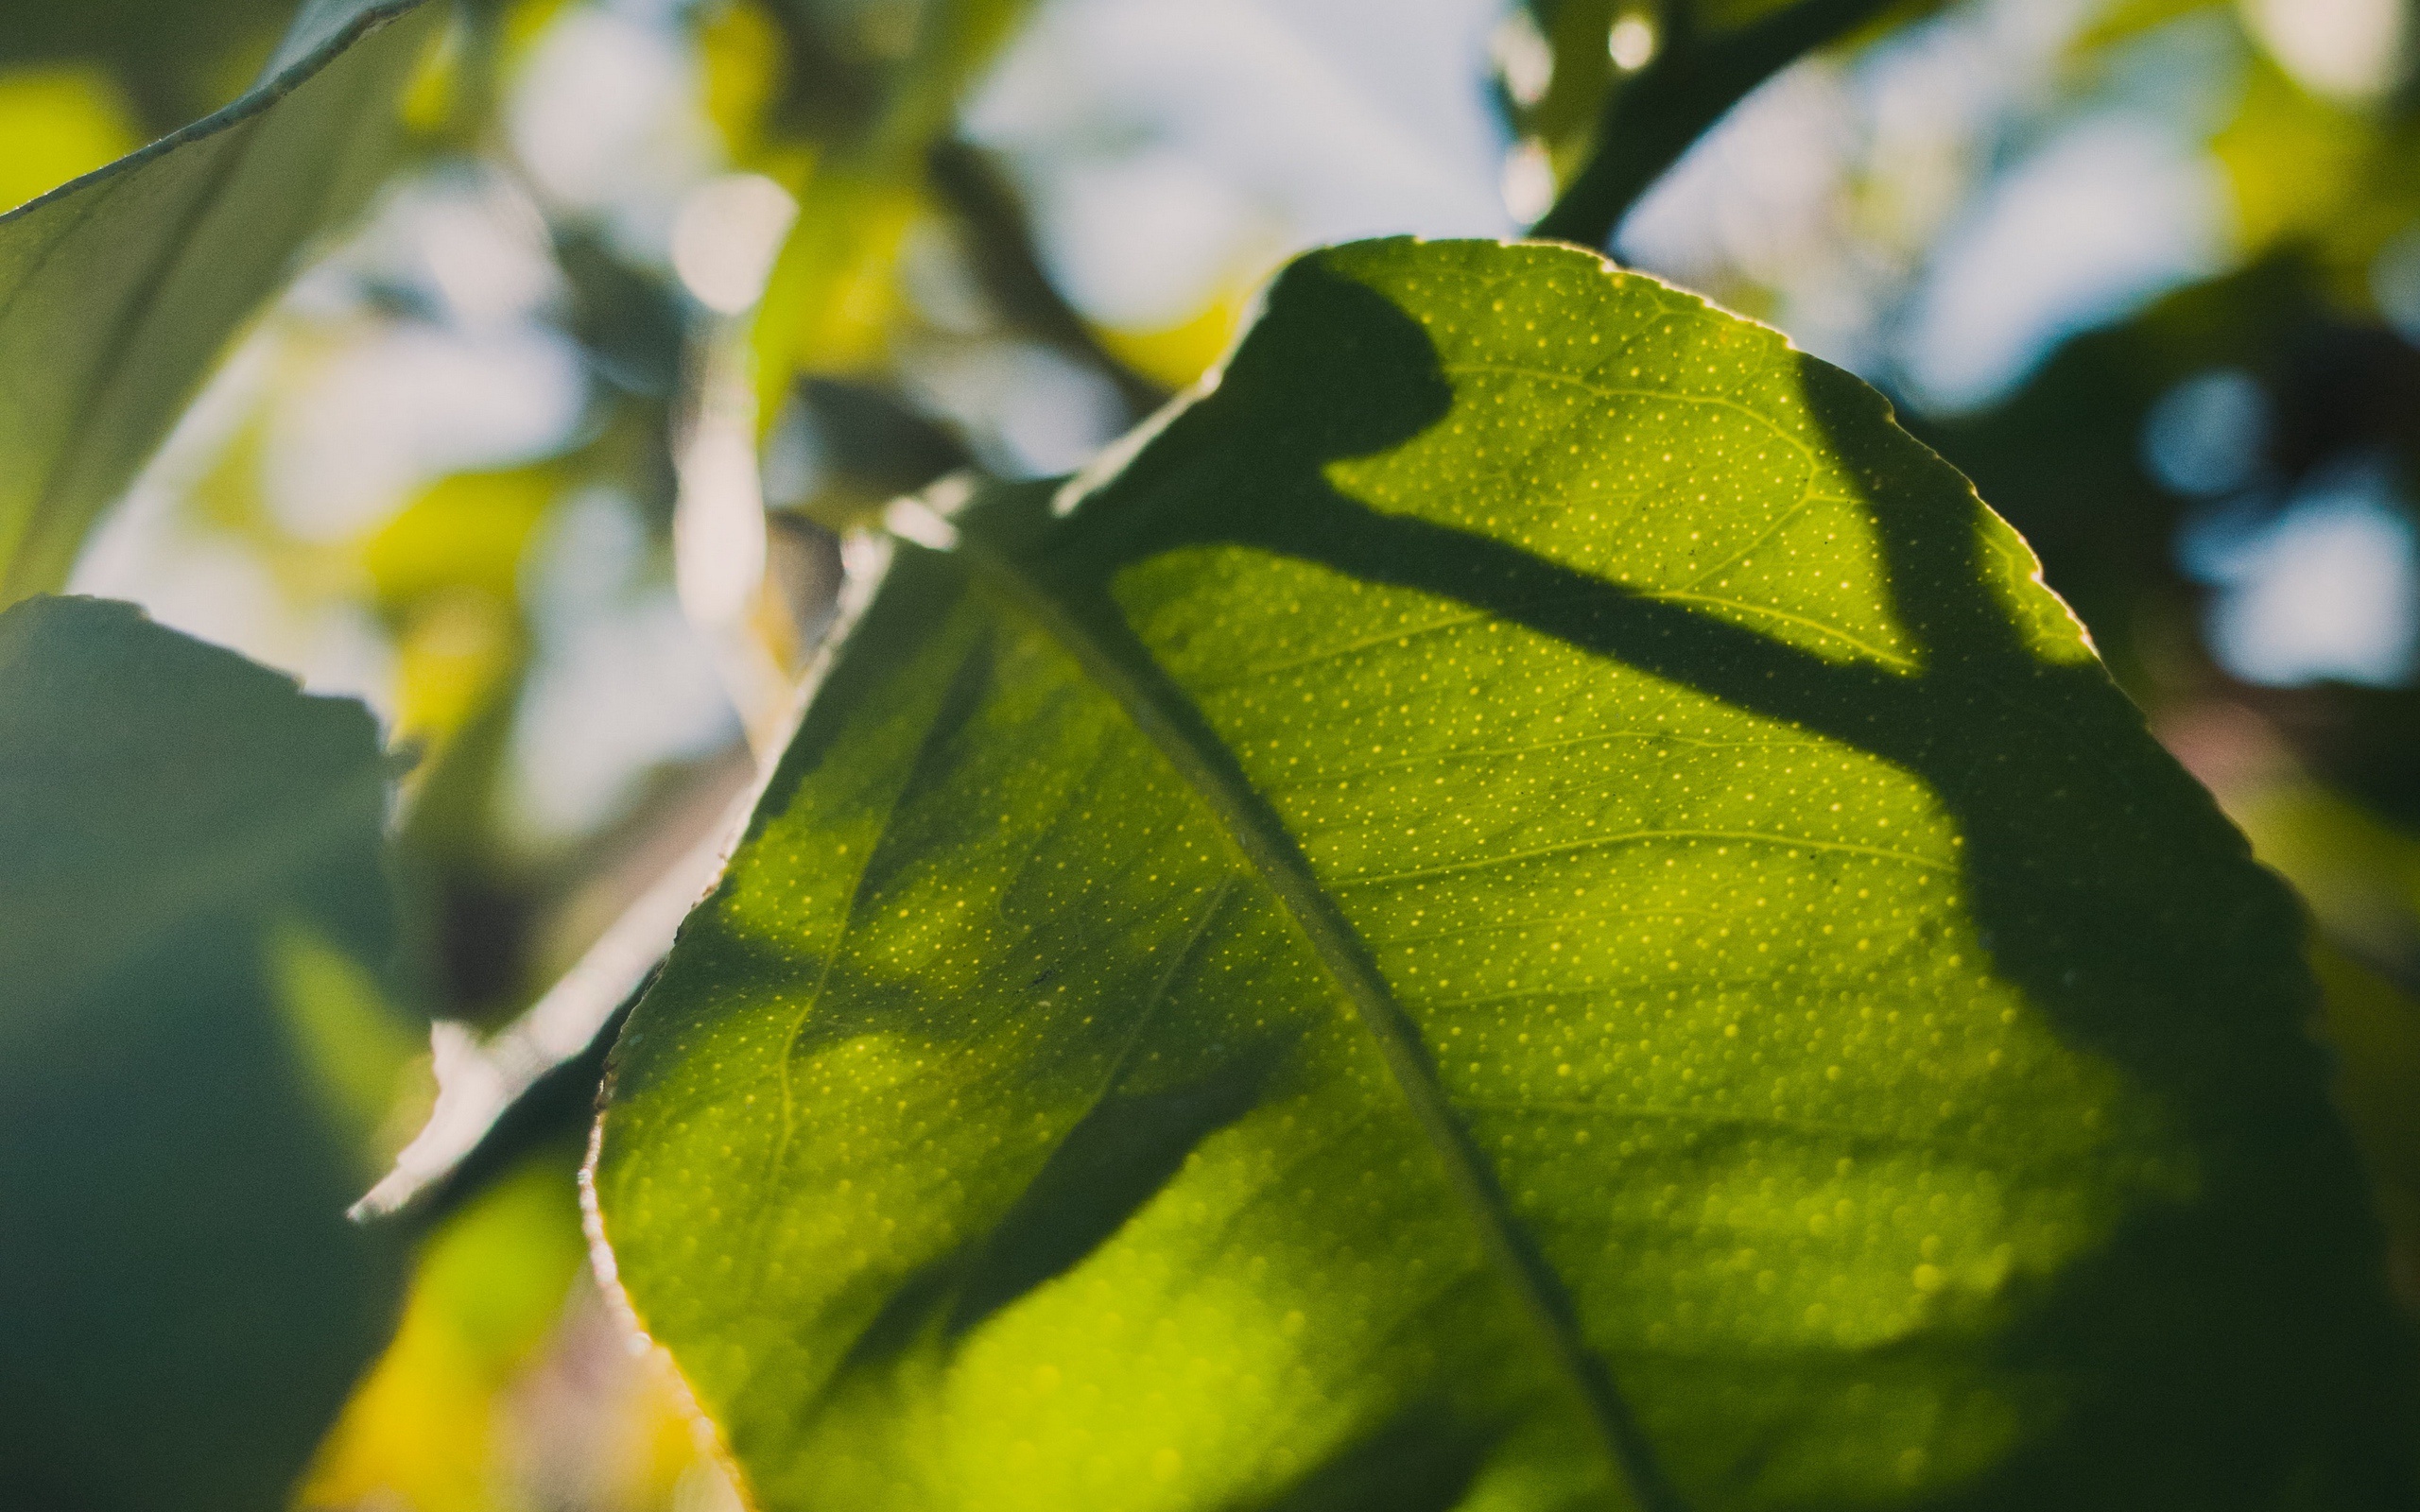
[943,530,1686,1512]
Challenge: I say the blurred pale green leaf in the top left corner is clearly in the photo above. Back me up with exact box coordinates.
[0,0,442,605]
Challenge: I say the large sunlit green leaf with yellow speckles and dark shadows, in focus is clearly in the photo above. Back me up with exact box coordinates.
[593,239,2411,1512]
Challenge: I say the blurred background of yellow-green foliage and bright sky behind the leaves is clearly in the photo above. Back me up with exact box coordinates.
[0,0,2420,1512]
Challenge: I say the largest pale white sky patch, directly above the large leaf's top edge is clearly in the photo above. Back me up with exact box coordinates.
[965,0,1512,329]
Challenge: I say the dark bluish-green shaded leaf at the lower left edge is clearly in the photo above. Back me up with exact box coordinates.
[0,597,402,1512]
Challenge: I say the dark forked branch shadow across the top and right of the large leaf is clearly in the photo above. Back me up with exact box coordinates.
[987,261,2415,1512]
